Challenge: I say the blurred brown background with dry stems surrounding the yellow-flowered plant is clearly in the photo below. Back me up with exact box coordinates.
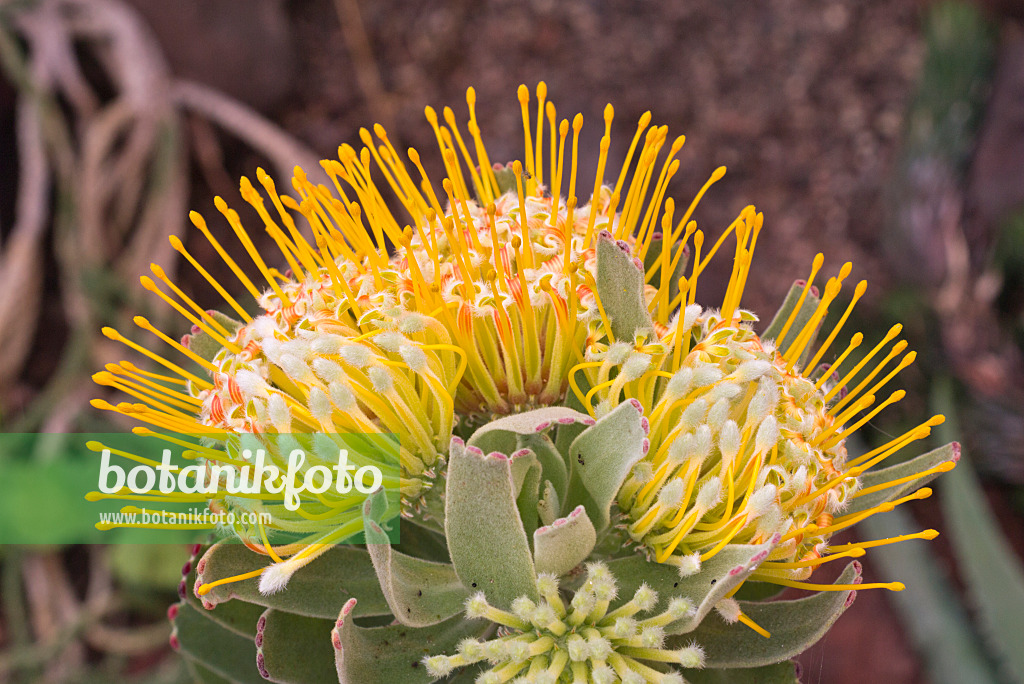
[0,0,1024,684]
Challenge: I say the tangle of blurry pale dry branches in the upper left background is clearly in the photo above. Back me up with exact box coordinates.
[0,0,318,430]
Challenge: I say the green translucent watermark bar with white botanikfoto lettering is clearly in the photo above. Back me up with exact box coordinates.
[0,432,401,547]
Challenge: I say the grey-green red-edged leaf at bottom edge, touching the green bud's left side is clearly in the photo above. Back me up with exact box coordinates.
[331,599,490,684]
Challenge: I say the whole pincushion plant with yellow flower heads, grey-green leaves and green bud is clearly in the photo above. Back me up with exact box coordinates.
[96,84,958,682]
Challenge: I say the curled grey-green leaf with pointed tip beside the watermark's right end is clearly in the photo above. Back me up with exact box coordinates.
[364,501,469,627]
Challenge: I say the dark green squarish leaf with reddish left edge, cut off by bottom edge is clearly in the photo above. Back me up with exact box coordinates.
[255,608,336,684]
